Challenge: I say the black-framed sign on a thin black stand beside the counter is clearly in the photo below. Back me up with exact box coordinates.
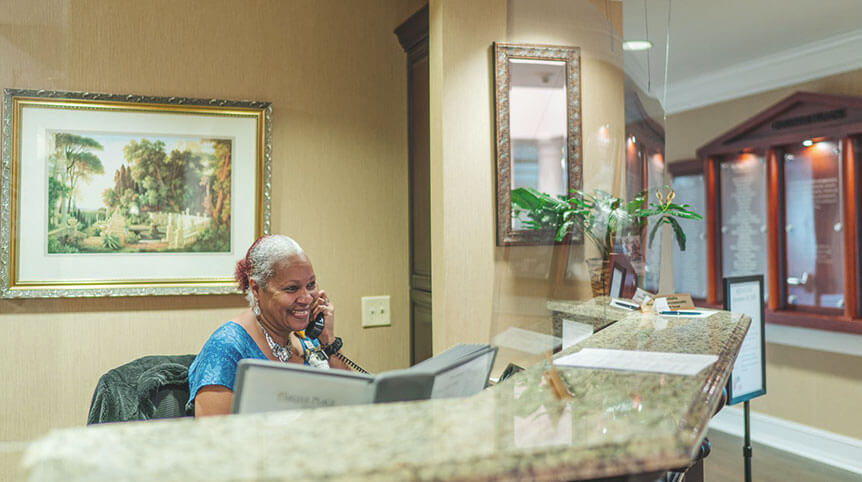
[724,275,766,482]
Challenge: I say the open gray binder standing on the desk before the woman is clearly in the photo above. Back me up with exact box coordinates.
[233,344,497,413]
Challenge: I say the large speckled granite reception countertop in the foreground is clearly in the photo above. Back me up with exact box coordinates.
[20,312,750,481]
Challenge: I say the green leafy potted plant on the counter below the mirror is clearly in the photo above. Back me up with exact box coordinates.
[512,186,703,294]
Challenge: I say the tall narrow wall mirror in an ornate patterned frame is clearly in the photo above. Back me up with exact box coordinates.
[494,43,583,246]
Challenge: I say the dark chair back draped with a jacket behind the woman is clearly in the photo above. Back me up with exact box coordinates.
[87,355,196,425]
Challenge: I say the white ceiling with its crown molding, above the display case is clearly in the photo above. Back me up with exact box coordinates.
[622,0,862,113]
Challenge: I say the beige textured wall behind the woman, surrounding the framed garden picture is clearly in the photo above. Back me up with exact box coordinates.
[0,0,424,472]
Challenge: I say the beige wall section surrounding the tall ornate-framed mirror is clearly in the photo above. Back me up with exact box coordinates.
[430,0,625,370]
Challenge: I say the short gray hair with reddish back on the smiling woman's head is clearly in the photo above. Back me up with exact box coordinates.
[236,234,305,306]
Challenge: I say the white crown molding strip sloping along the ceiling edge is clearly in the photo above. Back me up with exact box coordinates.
[664,29,862,114]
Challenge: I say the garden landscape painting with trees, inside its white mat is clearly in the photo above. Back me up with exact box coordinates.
[47,131,232,254]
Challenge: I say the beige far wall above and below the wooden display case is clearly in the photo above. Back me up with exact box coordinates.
[667,70,862,438]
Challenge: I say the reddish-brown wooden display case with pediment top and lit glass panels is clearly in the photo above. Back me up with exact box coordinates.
[697,92,862,333]
